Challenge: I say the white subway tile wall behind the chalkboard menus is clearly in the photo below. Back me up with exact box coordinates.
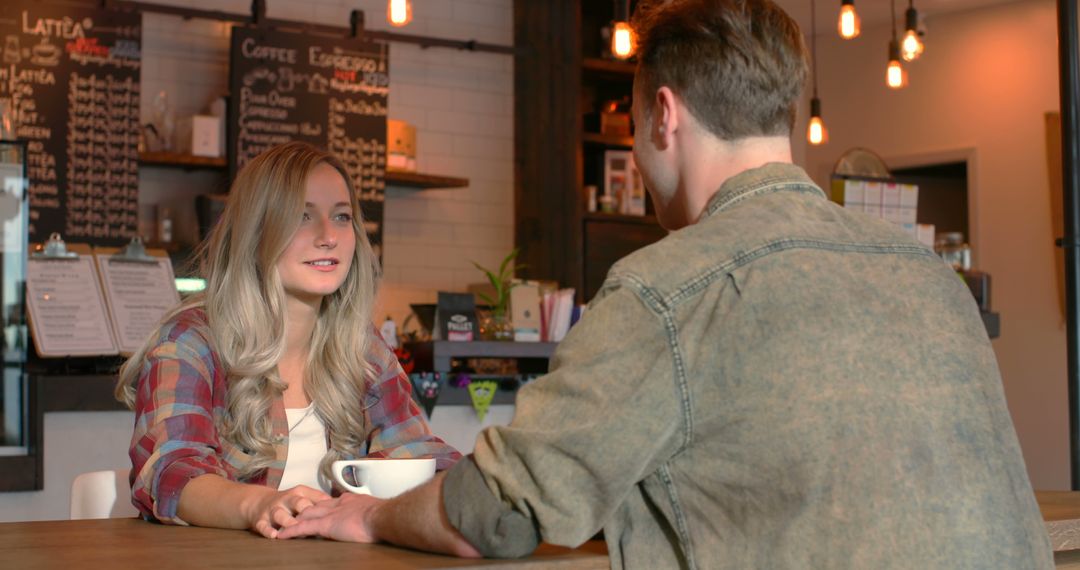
[139,0,514,324]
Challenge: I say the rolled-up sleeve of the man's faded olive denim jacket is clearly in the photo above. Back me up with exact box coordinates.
[443,287,687,557]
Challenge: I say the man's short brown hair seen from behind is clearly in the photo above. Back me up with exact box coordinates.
[633,0,808,140]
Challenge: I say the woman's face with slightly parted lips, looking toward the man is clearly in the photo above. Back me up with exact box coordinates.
[278,164,356,302]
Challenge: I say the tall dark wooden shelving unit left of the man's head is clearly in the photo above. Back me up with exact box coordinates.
[514,1,666,302]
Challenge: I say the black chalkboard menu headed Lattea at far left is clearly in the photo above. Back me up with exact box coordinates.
[0,0,141,245]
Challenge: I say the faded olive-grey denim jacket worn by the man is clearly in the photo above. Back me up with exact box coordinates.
[444,164,1053,570]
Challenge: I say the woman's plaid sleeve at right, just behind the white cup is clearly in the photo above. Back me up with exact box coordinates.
[361,329,461,471]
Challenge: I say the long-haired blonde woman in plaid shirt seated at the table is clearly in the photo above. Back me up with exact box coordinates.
[117,143,460,538]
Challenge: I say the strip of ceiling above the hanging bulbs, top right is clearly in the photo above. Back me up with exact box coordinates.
[774,0,1022,36]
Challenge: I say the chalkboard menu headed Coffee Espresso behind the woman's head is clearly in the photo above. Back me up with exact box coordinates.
[229,27,390,254]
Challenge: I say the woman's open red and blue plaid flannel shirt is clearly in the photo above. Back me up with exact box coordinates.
[129,309,461,525]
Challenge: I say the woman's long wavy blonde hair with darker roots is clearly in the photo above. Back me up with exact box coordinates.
[116,143,378,478]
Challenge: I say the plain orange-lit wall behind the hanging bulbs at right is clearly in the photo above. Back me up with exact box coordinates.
[802,0,1069,489]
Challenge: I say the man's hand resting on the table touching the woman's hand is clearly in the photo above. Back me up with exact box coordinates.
[276,493,386,542]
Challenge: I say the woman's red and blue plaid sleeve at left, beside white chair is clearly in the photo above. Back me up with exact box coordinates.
[130,326,230,525]
